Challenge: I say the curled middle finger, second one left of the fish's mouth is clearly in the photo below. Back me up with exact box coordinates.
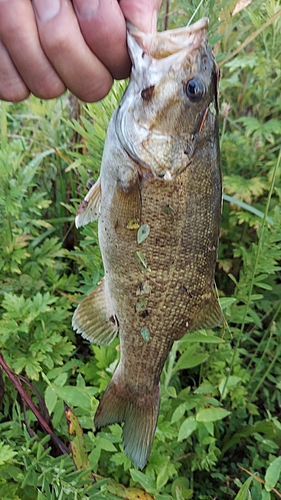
[33,0,112,102]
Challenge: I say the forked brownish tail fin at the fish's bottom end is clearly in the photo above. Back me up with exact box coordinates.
[94,369,160,469]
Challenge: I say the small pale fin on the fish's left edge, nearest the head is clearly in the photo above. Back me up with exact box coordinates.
[75,177,101,227]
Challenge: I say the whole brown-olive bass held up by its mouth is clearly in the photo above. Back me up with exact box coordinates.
[73,18,222,469]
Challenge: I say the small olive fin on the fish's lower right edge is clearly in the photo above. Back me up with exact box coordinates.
[188,290,223,332]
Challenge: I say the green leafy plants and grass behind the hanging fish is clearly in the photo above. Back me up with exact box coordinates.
[0,0,281,500]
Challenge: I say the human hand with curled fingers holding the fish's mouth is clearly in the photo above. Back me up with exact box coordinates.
[0,0,162,102]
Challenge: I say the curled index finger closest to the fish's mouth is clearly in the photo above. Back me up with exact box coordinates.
[73,0,131,79]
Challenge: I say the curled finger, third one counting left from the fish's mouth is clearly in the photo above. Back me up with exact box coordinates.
[0,0,65,100]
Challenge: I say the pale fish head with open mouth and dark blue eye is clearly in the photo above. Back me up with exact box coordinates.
[116,18,218,181]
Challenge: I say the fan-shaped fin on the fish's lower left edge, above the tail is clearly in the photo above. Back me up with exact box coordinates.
[72,279,118,345]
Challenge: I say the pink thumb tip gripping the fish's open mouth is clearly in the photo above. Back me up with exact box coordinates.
[120,0,162,33]
